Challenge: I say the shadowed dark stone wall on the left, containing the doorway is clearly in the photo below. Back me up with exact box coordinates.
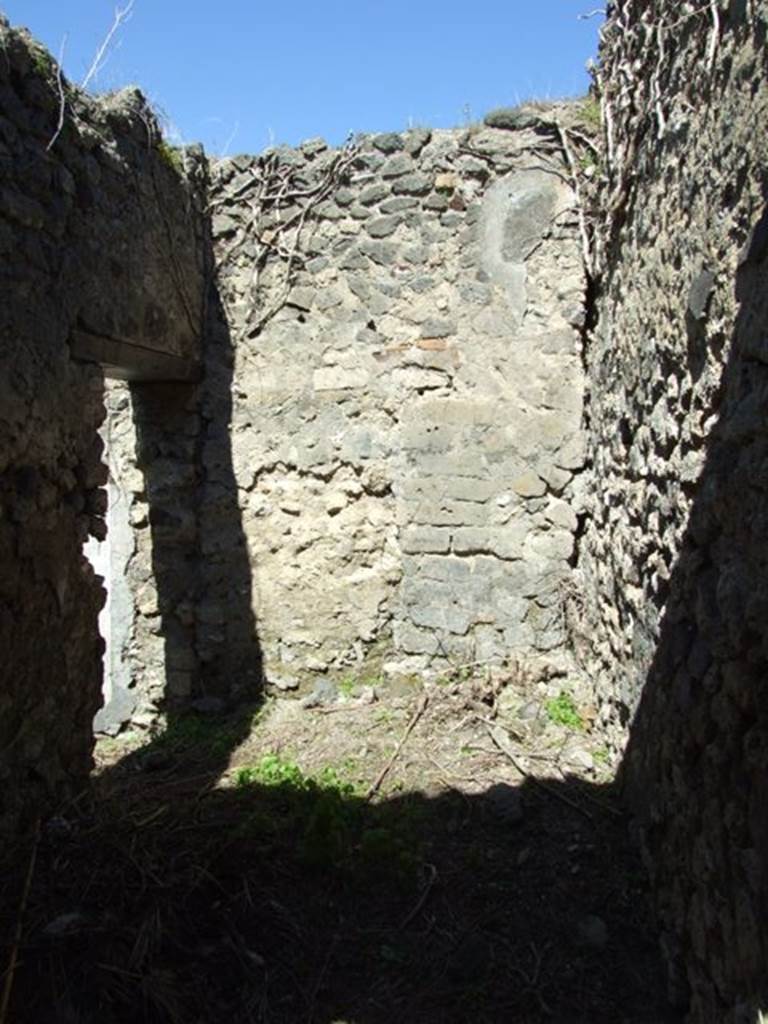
[0,20,203,826]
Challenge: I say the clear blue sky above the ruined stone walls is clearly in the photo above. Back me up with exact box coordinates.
[0,0,601,155]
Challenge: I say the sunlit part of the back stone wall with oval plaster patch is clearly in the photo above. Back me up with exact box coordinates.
[195,119,585,686]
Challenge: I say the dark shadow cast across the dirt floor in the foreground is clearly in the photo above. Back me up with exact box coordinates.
[3,708,679,1024]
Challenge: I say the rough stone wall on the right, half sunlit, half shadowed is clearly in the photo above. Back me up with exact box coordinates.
[573,0,768,1024]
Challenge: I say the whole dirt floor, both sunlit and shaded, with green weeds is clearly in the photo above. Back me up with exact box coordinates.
[0,673,677,1024]
